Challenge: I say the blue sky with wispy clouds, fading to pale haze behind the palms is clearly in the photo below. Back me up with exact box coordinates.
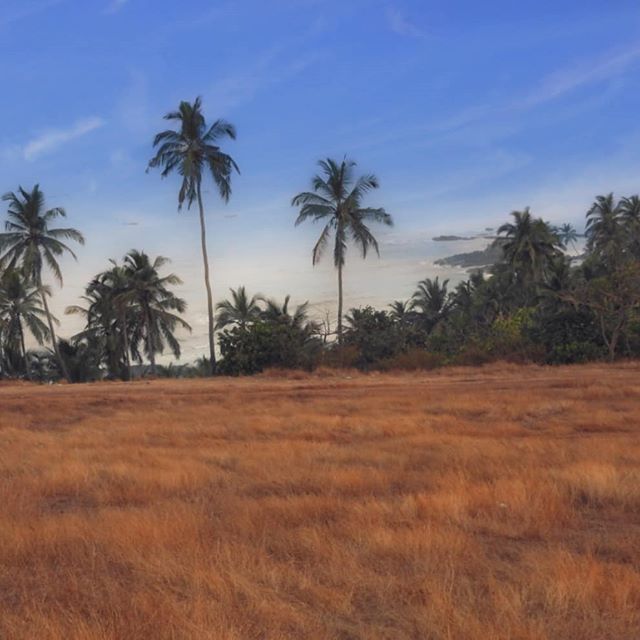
[0,0,640,359]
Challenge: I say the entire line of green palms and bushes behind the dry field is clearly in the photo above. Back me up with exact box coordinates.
[0,98,640,382]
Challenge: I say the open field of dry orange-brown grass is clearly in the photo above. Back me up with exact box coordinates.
[0,364,640,640]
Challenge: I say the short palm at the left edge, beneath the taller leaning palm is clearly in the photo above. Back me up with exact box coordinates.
[0,269,49,377]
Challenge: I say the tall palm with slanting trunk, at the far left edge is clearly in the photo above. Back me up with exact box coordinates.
[0,185,84,380]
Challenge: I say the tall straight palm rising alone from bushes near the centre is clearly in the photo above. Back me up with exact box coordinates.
[291,158,393,343]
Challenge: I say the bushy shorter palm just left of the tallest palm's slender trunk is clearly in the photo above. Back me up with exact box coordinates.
[119,250,191,375]
